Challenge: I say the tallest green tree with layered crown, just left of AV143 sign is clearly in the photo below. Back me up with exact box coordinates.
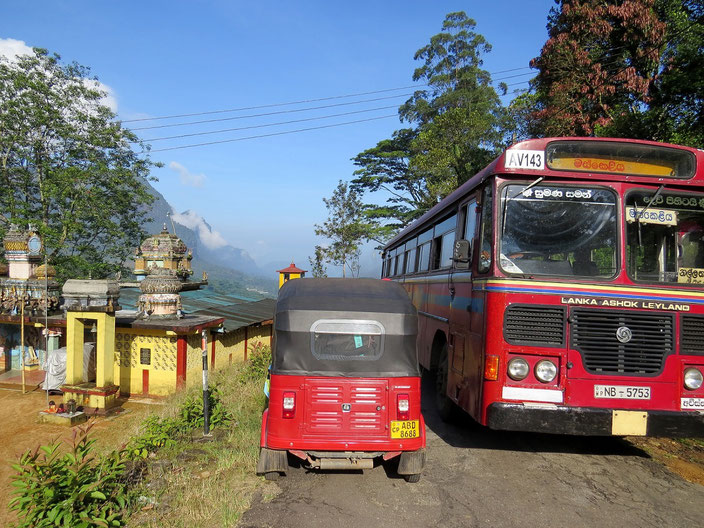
[400,11,508,187]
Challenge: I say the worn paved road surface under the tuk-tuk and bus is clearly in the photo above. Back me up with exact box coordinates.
[240,378,704,528]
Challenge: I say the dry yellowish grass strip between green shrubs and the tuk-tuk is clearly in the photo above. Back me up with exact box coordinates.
[127,364,265,528]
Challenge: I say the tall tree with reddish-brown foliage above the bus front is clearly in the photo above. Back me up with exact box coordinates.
[529,0,665,136]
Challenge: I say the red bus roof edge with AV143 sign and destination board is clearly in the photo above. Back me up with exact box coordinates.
[384,137,704,251]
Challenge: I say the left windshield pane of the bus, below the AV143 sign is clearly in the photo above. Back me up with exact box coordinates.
[498,184,618,278]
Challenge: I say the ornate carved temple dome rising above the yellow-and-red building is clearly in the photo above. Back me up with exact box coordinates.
[134,224,193,280]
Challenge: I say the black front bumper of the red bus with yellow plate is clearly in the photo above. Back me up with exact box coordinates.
[487,402,704,437]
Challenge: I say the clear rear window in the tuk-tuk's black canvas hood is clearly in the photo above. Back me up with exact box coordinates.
[310,319,386,361]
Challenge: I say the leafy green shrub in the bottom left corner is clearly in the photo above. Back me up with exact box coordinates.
[10,424,127,528]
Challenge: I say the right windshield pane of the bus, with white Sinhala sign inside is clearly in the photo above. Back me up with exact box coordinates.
[625,190,704,285]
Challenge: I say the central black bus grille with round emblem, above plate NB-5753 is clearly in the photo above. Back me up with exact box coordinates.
[570,308,675,375]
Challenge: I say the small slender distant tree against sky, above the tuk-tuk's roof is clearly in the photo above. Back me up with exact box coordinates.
[315,181,369,277]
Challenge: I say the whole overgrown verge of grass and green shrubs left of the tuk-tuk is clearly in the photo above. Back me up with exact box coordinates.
[11,354,270,528]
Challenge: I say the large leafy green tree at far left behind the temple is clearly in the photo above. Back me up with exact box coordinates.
[0,49,153,278]
